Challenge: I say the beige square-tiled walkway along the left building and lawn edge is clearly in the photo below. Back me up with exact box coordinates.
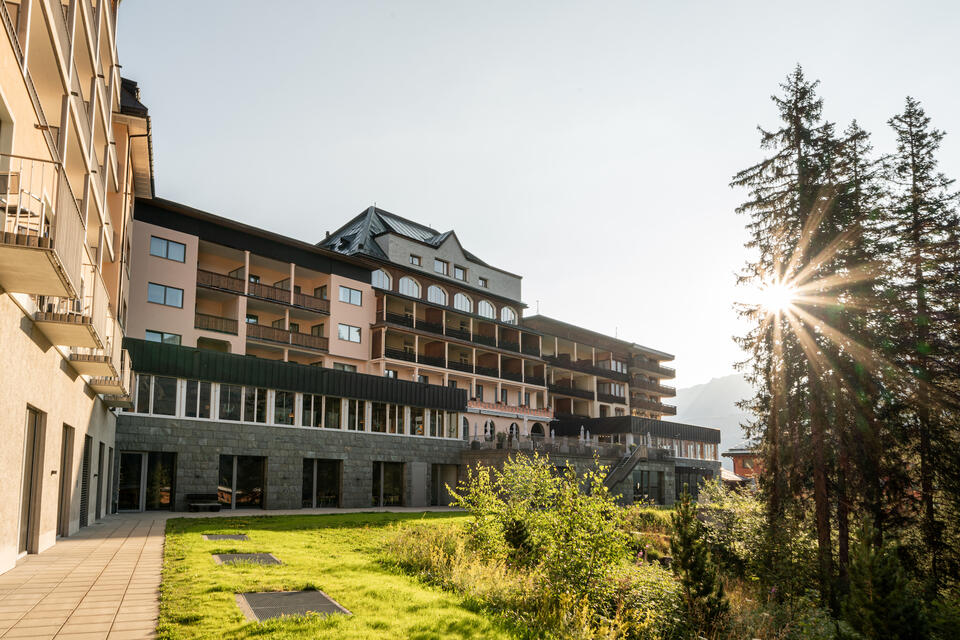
[0,507,458,640]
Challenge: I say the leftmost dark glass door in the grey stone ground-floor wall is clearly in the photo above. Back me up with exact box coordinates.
[117,451,177,511]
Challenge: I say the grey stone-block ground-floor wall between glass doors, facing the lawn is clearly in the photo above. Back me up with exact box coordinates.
[117,414,466,510]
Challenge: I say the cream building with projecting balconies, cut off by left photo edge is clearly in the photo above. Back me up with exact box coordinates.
[0,0,153,572]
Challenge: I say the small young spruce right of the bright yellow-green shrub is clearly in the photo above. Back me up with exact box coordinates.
[670,484,730,637]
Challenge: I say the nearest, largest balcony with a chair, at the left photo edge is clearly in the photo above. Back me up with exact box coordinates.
[0,154,86,298]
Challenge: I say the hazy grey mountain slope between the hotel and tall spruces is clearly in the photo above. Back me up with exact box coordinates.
[674,373,753,468]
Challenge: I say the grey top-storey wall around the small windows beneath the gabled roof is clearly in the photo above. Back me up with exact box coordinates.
[377,233,521,304]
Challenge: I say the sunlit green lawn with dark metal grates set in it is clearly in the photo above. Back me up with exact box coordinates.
[157,513,517,640]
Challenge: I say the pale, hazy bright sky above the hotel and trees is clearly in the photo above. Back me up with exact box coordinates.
[118,0,960,388]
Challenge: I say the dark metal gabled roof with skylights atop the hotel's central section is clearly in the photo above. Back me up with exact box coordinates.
[317,207,502,271]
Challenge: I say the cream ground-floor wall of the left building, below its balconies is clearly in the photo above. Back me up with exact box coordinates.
[0,293,116,573]
